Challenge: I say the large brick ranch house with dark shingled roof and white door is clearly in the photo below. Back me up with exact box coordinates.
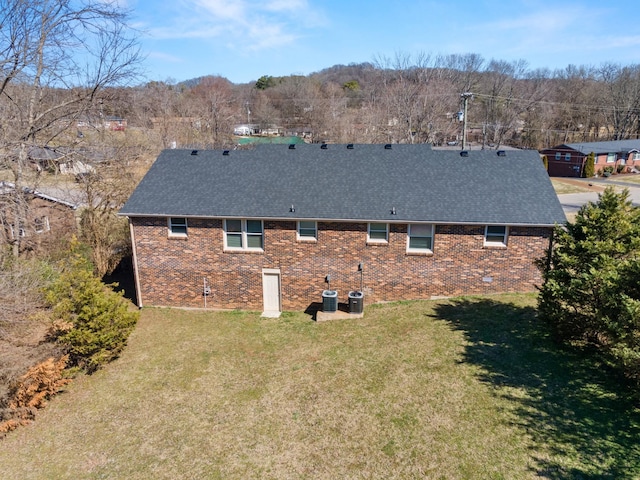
[120,144,566,315]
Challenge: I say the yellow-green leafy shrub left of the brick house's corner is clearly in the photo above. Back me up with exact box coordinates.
[46,242,139,373]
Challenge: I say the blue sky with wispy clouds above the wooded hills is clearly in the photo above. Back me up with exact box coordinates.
[127,0,640,83]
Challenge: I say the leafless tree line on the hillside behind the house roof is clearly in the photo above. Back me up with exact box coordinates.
[108,54,640,149]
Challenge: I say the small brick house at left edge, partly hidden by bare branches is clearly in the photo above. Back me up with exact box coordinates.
[0,182,76,253]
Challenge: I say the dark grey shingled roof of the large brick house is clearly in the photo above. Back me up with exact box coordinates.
[120,144,565,225]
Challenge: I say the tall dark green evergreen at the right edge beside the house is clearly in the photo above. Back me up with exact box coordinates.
[538,188,640,382]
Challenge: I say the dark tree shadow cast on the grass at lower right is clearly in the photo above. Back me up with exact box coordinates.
[436,298,640,479]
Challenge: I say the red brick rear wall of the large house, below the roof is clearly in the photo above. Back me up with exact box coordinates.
[132,218,551,310]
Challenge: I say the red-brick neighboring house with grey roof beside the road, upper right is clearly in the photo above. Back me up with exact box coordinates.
[540,140,640,177]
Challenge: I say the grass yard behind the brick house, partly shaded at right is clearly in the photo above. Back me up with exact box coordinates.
[0,295,640,480]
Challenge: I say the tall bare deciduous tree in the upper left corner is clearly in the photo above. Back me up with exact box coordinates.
[0,0,141,256]
